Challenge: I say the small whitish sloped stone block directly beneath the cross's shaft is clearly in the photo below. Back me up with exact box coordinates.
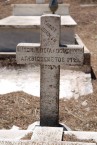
[31,126,63,142]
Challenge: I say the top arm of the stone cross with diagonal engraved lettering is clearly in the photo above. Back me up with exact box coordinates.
[41,15,60,48]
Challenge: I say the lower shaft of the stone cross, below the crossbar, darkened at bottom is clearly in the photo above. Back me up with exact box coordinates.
[40,65,60,126]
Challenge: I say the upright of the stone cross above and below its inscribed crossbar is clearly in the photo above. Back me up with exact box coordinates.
[40,15,60,126]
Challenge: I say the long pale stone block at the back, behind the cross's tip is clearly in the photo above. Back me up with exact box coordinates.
[13,3,69,16]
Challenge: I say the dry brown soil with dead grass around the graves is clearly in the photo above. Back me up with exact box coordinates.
[0,0,97,134]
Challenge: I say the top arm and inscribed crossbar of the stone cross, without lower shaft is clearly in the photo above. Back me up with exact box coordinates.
[16,14,84,66]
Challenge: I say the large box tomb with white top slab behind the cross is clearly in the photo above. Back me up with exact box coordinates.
[0,15,76,52]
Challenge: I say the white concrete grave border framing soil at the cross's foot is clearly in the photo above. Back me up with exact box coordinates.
[0,130,97,145]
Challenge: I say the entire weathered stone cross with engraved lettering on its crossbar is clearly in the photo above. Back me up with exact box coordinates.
[16,14,83,126]
